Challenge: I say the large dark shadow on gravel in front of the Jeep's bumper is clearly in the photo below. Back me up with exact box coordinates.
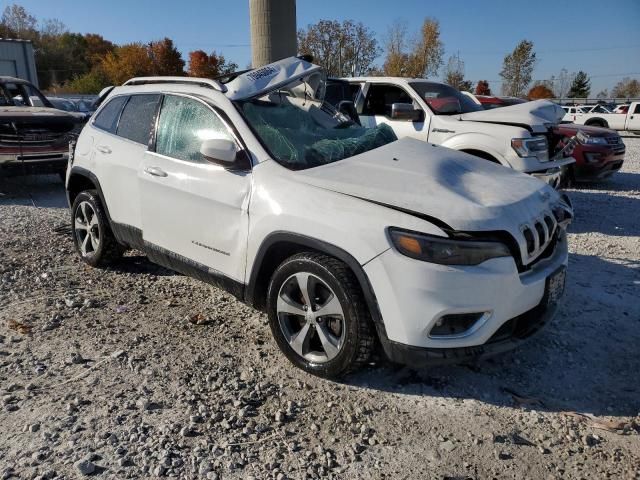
[346,255,640,416]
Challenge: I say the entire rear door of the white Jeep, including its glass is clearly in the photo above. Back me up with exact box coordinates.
[93,94,160,228]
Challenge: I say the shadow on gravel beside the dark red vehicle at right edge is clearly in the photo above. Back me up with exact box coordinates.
[569,189,640,237]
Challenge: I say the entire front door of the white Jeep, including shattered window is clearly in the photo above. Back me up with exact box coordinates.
[138,95,251,283]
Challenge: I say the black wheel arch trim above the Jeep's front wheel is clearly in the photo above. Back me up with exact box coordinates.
[244,231,386,339]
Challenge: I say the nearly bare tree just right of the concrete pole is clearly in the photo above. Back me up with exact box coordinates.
[298,20,380,77]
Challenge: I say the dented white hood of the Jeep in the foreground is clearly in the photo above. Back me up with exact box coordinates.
[297,137,560,234]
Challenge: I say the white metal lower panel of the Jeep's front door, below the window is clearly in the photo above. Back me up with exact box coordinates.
[139,152,251,282]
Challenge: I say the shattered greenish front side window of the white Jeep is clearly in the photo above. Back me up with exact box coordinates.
[156,95,233,162]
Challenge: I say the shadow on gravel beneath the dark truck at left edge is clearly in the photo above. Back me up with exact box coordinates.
[0,174,68,208]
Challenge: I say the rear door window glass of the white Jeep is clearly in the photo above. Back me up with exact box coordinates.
[116,95,160,145]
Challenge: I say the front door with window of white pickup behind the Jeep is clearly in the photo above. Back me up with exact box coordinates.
[358,83,428,140]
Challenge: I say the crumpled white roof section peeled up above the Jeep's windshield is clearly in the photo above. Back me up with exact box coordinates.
[226,57,322,100]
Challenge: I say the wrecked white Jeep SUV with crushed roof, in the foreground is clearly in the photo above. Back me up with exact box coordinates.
[66,58,572,377]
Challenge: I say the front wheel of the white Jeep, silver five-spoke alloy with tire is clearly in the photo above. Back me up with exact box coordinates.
[267,253,375,378]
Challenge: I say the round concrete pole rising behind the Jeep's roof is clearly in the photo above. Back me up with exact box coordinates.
[249,0,298,68]
